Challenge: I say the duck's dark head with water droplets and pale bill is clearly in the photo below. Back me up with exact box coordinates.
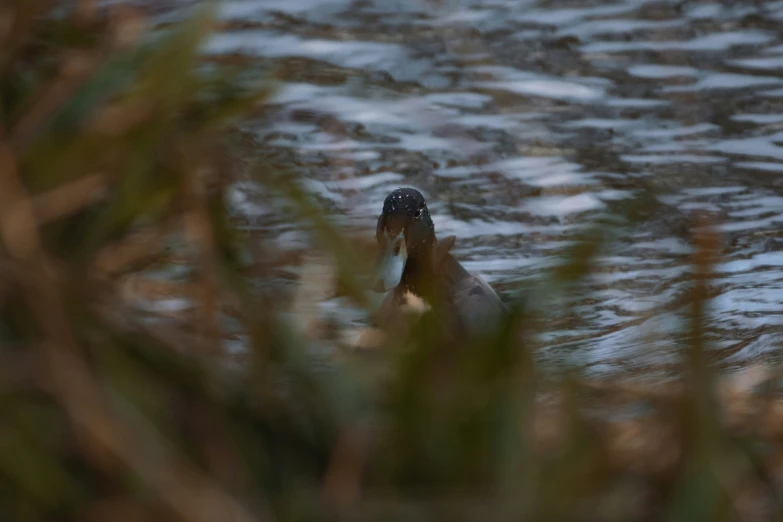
[373,188,436,292]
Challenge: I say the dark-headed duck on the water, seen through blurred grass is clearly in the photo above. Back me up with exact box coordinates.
[372,187,508,338]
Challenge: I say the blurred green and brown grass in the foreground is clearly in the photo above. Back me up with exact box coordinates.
[0,1,783,521]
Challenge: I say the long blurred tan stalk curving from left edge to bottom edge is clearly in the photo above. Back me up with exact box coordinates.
[0,134,264,522]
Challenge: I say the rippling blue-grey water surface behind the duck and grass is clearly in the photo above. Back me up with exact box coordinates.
[190,0,783,372]
